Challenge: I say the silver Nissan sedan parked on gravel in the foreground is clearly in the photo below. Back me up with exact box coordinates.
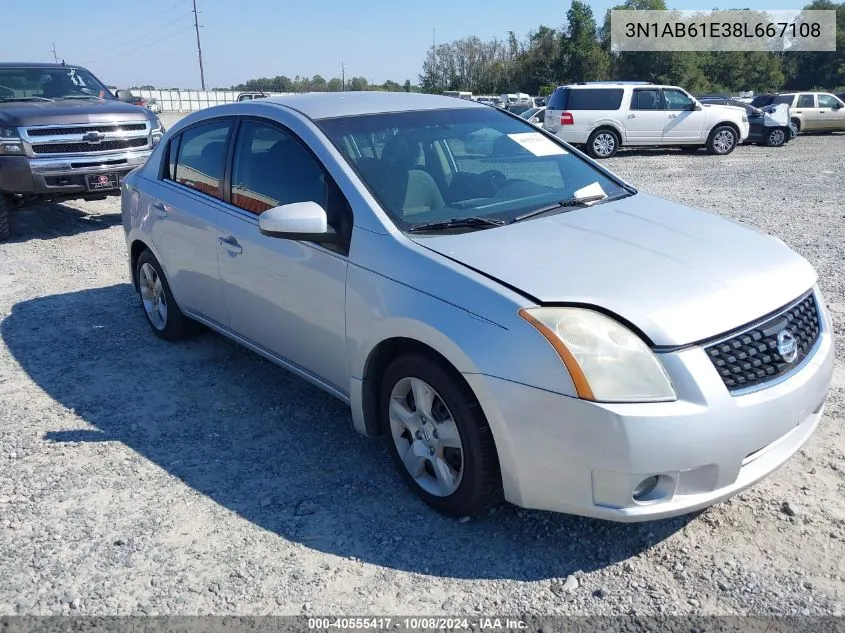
[122,93,833,521]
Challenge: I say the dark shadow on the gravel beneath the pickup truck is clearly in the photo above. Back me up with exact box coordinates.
[4,198,123,243]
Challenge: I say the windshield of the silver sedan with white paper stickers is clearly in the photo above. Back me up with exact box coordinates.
[317,107,626,230]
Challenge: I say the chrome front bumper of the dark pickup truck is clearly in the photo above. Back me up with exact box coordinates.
[0,149,152,196]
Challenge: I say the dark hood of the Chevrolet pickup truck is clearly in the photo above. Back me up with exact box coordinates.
[0,99,151,127]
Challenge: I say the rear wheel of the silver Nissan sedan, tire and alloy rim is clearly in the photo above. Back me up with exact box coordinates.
[135,250,198,341]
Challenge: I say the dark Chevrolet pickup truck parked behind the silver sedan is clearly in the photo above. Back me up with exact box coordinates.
[0,63,164,241]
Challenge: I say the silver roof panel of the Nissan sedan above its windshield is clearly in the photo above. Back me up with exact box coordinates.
[261,91,487,119]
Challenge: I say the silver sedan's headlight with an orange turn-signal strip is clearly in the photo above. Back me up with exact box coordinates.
[519,308,677,402]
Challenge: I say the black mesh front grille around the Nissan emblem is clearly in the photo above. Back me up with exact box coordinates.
[704,293,820,392]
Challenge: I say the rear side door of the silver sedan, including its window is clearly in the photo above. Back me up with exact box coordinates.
[147,118,233,324]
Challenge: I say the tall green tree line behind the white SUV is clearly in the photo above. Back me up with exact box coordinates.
[419,0,845,95]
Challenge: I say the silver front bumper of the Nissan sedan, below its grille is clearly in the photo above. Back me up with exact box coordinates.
[465,288,833,522]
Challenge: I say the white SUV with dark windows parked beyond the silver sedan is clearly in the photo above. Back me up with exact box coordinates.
[543,82,749,158]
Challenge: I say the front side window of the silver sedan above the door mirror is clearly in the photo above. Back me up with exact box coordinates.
[232,120,328,214]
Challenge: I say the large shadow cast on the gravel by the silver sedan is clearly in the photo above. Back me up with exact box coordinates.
[0,284,691,580]
